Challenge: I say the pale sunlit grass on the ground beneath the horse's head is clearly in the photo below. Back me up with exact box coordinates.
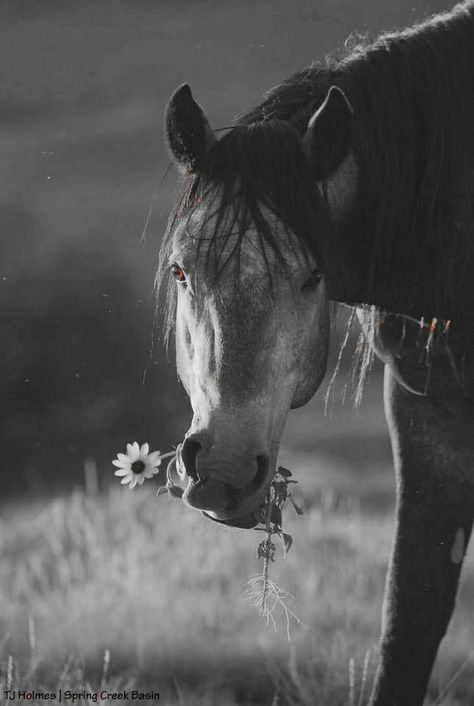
[0,472,474,706]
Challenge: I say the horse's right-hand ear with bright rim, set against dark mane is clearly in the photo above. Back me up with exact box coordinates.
[303,86,353,181]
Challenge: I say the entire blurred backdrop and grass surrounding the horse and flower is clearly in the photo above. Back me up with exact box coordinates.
[0,0,474,706]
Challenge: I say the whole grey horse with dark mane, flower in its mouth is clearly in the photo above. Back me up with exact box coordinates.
[157,0,474,706]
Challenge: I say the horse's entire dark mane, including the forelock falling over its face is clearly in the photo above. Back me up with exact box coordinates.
[158,0,474,340]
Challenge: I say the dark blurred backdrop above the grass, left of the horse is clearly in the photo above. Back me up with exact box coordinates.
[0,0,456,496]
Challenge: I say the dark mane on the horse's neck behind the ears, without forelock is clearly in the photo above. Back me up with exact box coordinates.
[239,1,474,315]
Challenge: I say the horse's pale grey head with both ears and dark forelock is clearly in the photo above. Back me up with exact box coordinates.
[160,85,350,527]
